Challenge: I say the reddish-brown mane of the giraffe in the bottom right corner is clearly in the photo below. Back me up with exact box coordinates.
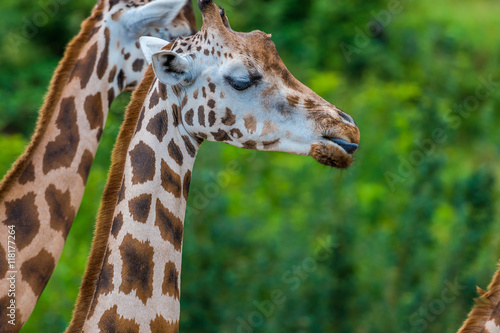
[458,264,500,333]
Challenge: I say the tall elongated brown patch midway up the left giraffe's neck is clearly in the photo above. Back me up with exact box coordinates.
[43,97,80,174]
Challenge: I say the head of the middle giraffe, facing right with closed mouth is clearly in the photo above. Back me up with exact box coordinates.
[141,0,359,168]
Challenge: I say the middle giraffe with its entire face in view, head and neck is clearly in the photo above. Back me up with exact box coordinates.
[67,0,359,333]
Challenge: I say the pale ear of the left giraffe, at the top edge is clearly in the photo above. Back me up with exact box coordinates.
[121,0,186,35]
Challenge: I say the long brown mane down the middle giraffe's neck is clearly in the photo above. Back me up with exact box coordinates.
[66,67,155,333]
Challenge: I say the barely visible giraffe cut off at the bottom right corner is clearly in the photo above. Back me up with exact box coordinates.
[458,266,500,333]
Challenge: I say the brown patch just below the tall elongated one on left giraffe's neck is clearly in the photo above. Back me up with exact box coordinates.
[45,185,76,238]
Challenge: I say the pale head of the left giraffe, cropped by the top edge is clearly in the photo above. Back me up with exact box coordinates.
[86,0,196,91]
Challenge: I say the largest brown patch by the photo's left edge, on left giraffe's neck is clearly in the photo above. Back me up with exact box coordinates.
[3,192,40,251]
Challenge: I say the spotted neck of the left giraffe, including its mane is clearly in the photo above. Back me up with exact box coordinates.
[0,2,127,331]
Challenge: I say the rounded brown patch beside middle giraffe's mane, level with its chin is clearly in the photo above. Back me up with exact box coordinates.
[130,141,156,185]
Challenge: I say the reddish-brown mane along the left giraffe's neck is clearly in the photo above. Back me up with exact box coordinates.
[0,2,104,201]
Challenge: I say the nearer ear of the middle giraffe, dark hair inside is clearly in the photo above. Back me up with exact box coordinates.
[152,51,194,85]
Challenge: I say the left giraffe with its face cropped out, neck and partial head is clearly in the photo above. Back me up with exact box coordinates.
[0,0,196,332]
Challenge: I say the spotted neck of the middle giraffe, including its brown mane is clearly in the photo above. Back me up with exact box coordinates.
[69,71,198,332]
